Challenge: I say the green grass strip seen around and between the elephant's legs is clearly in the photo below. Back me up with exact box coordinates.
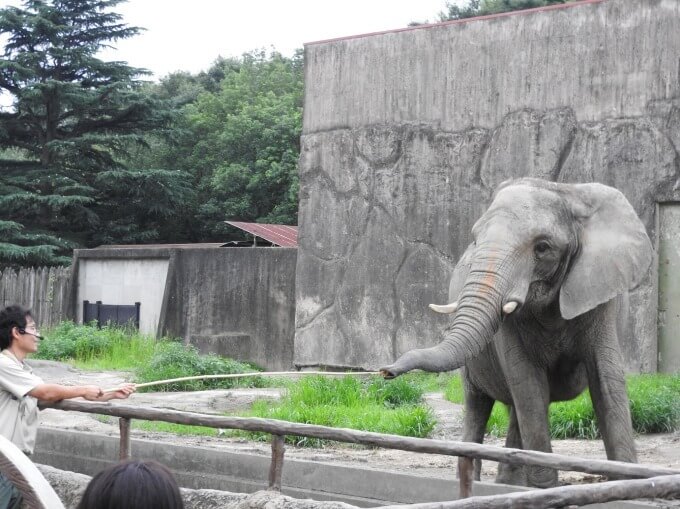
[444,374,680,439]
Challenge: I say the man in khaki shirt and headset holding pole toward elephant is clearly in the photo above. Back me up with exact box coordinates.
[0,305,135,509]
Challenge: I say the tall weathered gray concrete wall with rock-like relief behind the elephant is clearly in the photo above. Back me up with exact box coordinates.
[295,0,680,371]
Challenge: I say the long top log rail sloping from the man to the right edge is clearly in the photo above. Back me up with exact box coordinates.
[39,400,680,478]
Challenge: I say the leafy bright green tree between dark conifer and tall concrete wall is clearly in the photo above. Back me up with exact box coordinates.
[155,51,303,242]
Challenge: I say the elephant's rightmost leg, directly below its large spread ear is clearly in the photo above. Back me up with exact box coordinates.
[581,301,637,462]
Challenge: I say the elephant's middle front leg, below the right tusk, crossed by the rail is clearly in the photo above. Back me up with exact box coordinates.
[498,323,557,488]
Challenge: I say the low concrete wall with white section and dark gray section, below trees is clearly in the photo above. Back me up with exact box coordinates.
[73,245,297,370]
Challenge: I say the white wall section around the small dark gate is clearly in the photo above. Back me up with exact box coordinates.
[76,258,168,334]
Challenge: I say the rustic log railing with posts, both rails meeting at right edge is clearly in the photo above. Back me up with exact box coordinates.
[40,400,680,509]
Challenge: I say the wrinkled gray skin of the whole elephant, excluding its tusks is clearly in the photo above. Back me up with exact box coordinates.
[381,179,652,487]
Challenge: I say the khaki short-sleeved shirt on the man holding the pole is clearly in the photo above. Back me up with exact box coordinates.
[0,350,44,454]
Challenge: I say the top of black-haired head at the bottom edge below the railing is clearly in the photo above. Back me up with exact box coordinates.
[77,460,184,509]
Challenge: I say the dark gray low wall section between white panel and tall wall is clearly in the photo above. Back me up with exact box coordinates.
[161,248,297,370]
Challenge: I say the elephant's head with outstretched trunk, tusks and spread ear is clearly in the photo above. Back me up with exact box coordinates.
[381,179,652,377]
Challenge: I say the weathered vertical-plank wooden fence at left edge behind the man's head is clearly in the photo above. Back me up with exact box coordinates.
[0,267,72,327]
